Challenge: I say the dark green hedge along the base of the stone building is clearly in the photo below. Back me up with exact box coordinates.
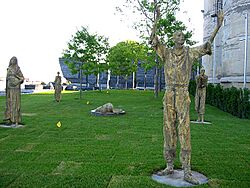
[189,80,250,119]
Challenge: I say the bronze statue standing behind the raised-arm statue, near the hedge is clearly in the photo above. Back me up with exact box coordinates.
[195,68,208,123]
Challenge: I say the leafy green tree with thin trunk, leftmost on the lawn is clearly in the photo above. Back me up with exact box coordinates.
[63,27,109,98]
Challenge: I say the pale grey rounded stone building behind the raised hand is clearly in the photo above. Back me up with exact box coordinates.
[202,0,250,88]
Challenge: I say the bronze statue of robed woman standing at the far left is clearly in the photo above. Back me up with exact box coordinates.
[5,57,24,125]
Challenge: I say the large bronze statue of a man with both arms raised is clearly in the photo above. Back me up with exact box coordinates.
[150,7,224,184]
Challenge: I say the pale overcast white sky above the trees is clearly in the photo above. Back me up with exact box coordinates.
[0,0,203,82]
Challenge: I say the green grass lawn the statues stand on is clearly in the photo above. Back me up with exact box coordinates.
[0,90,250,188]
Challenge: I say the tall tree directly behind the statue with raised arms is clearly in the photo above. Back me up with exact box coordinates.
[117,0,194,97]
